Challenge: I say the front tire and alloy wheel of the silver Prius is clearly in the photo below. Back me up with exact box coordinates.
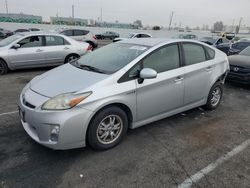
[87,106,128,150]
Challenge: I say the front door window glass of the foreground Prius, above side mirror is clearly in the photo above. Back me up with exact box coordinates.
[143,44,180,73]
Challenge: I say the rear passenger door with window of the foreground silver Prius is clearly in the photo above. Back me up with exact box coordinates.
[182,43,215,105]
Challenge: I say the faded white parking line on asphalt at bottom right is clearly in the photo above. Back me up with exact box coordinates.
[178,139,250,188]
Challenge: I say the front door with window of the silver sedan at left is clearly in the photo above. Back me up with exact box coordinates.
[9,35,45,68]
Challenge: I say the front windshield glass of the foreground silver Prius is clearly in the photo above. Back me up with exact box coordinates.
[78,43,148,74]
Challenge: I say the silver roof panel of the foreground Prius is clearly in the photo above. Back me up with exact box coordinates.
[118,38,202,47]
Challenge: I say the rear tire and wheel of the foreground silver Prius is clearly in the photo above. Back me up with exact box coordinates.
[204,82,223,110]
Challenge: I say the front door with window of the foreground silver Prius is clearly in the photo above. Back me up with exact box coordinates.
[136,44,184,121]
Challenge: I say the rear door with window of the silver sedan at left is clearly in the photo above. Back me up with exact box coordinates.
[44,35,71,66]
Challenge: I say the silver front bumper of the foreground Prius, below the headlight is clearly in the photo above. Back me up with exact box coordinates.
[19,90,93,150]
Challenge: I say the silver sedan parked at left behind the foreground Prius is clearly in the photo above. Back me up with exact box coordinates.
[0,32,89,75]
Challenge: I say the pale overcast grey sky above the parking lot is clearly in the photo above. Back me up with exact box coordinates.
[0,0,250,27]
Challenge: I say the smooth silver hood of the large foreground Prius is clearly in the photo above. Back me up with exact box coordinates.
[30,64,109,98]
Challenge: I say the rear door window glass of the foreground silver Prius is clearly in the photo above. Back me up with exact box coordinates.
[183,43,206,65]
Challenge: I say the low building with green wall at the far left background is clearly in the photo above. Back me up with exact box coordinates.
[0,13,42,24]
